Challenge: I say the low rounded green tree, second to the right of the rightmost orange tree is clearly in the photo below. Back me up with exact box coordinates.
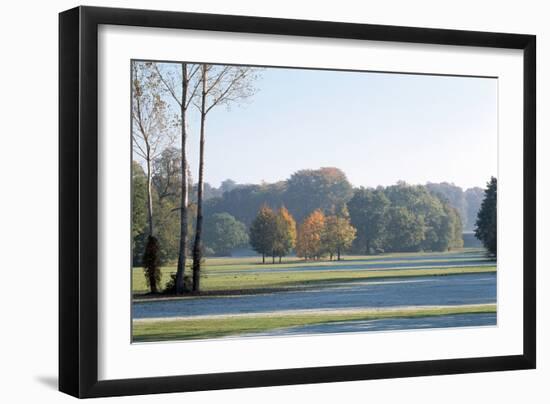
[386,206,425,251]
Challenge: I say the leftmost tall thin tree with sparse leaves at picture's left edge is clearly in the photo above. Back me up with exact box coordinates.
[132,62,174,236]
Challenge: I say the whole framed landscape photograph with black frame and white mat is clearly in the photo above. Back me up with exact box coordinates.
[59,7,536,397]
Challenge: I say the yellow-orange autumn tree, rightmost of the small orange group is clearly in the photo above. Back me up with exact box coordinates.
[321,205,357,261]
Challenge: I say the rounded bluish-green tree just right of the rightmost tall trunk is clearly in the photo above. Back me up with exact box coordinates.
[204,213,248,256]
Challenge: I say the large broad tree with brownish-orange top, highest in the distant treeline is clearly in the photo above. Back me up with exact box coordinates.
[285,167,353,221]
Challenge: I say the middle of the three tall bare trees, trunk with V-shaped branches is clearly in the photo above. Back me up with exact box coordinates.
[154,63,200,294]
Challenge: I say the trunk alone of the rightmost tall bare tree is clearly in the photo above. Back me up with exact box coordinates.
[193,65,207,292]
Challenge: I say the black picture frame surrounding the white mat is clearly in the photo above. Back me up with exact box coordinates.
[59,7,536,398]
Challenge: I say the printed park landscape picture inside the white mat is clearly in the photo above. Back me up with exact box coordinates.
[131,61,497,342]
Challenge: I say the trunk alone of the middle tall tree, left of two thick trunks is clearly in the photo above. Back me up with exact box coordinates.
[176,63,193,295]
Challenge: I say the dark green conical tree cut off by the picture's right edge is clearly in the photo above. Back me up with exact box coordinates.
[475,177,497,256]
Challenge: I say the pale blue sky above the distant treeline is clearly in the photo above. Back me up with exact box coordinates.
[147,63,498,189]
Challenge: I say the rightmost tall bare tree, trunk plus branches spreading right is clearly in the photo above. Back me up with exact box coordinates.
[193,64,257,292]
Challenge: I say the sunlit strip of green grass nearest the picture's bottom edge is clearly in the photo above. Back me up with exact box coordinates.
[133,304,496,342]
